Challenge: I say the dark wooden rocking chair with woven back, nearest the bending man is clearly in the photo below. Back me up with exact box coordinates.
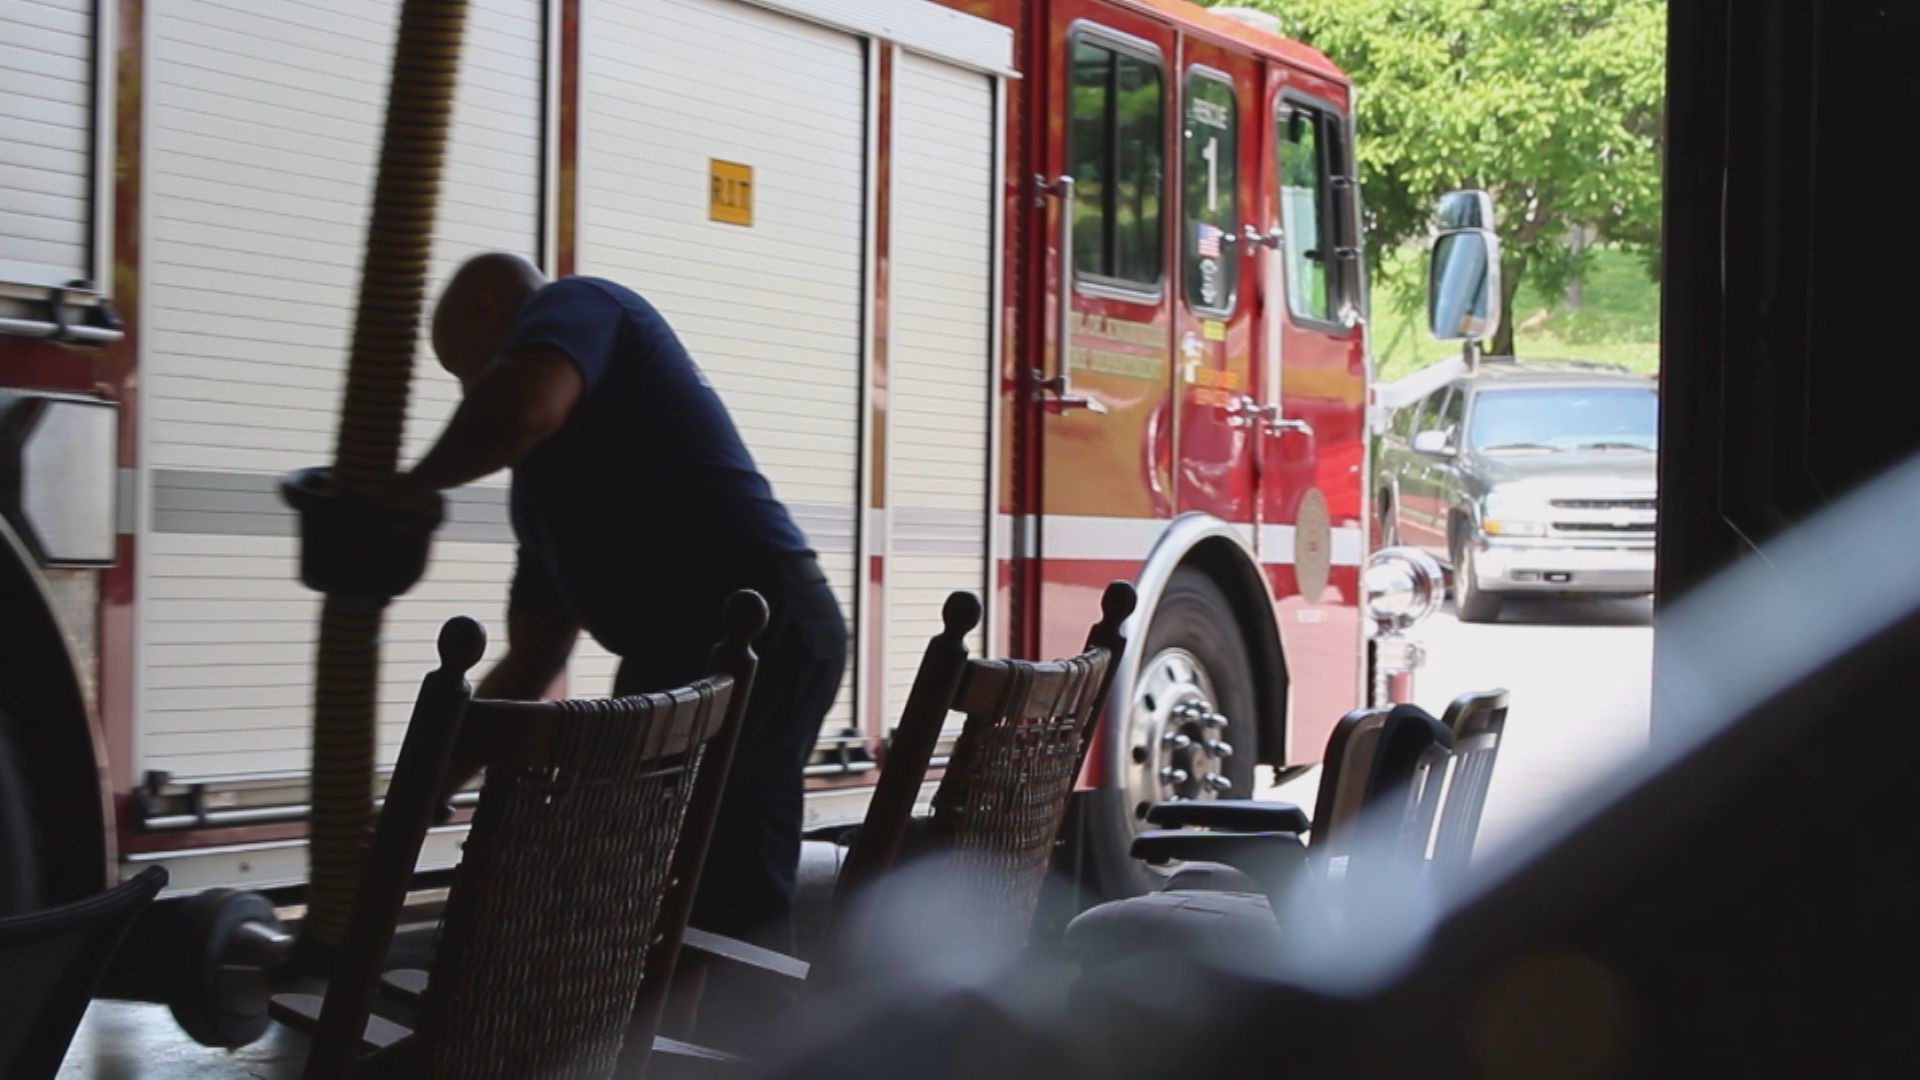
[273,592,766,1078]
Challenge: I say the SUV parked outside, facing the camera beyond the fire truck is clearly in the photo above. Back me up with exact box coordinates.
[1379,357,1659,623]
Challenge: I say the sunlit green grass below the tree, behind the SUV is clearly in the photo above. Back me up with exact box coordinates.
[1373,250,1661,380]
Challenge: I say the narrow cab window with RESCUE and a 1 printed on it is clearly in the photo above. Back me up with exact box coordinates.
[1181,67,1240,313]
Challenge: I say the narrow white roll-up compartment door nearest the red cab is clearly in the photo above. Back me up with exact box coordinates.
[885,54,996,734]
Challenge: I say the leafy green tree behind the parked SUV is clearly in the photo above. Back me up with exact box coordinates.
[1238,0,1667,354]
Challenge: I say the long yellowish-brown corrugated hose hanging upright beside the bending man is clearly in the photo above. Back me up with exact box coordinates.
[303,0,467,953]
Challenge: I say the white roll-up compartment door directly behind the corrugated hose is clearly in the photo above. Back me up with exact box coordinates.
[134,0,545,778]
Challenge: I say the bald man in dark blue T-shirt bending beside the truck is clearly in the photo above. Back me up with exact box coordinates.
[396,254,847,951]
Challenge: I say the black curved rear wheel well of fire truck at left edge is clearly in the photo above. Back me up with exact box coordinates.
[0,521,113,903]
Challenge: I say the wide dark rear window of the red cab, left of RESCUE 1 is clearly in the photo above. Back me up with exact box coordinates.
[1068,33,1165,290]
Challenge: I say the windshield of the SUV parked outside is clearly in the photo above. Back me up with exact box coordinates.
[1467,386,1659,452]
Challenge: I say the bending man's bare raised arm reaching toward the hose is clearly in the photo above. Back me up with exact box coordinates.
[407,346,586,492]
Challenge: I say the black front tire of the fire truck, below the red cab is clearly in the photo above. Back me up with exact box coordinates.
[1079,567,1260,899]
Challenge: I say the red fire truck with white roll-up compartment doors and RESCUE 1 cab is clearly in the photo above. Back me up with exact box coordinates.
[0,0,1443,1045]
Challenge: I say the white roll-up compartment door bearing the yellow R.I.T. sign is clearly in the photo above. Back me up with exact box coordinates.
[580,0,866,736]
